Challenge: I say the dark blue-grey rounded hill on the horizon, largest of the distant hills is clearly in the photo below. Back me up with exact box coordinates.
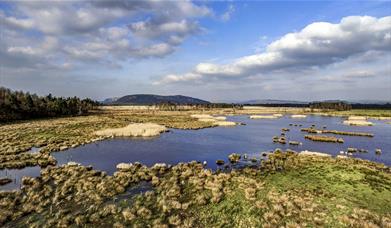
[102,94,210,105]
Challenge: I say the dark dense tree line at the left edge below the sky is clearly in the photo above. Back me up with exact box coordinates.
[0,87,99,122]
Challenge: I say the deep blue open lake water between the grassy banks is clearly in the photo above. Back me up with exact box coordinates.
[0,115,391,189]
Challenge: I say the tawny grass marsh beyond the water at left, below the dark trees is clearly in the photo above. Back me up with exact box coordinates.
[0,109,214,169]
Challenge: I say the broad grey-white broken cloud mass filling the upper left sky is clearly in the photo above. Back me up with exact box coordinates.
[0,0,213,70]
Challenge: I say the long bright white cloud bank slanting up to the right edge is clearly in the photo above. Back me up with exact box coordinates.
[156,16,391,84]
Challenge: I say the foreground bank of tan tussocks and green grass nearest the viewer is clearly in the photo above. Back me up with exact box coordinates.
[0,153,391,227]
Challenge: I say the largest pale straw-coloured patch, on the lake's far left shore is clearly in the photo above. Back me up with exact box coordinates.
[95,123,167,137]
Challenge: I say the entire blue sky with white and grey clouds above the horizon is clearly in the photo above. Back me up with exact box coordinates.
[0,0,391,102]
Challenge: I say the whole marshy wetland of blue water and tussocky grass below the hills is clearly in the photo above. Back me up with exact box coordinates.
[0,107,391,227]
